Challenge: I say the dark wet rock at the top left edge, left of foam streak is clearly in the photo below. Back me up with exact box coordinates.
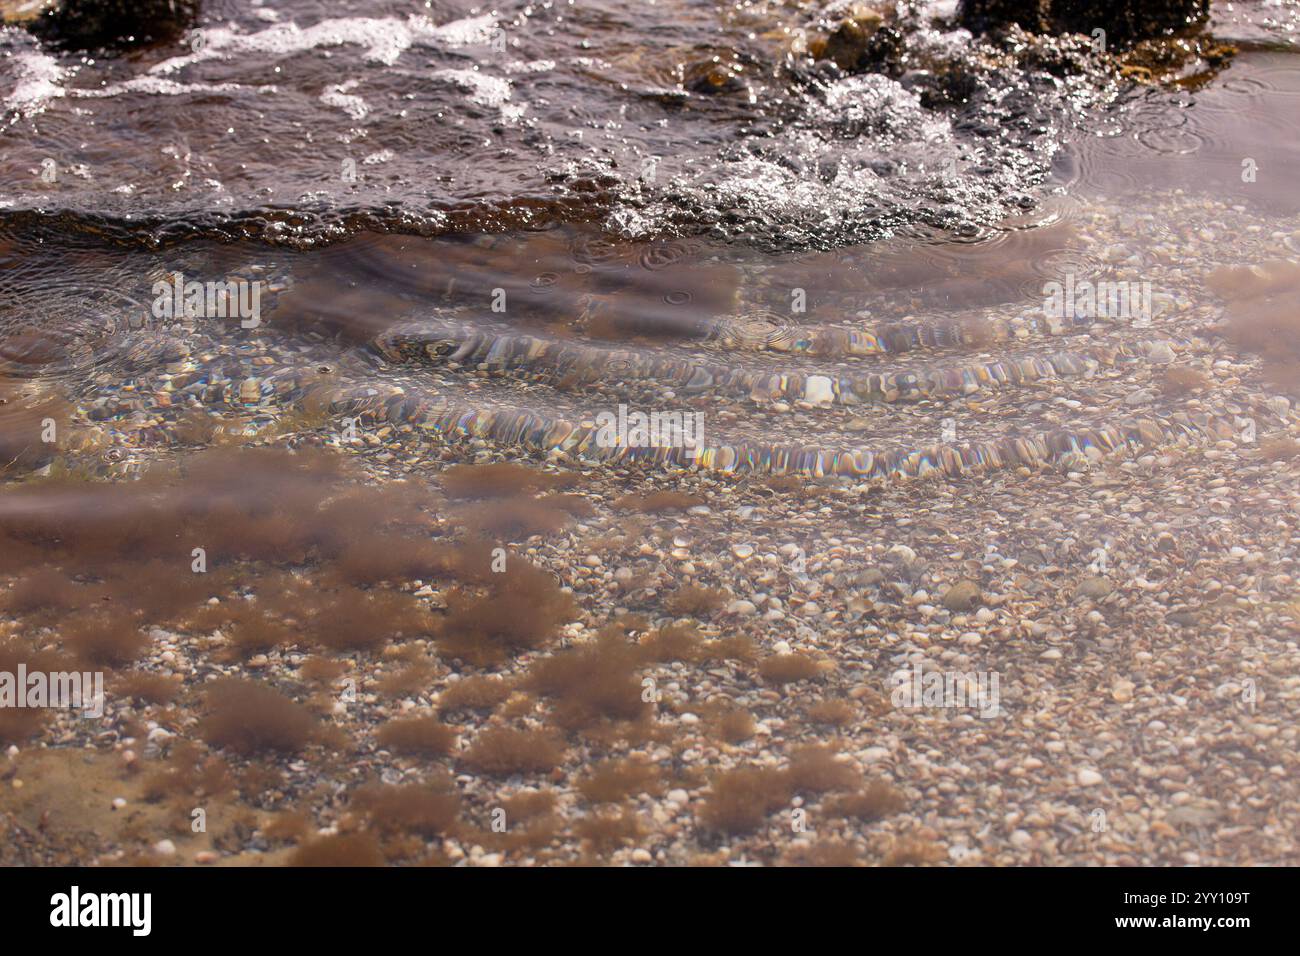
[30,0,200,49]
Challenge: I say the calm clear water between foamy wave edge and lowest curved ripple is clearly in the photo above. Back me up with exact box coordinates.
[3,32,1300,477]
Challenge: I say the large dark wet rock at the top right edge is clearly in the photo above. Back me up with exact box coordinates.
[958,0,1209,44]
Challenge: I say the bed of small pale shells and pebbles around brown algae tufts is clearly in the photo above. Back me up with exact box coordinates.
[0,187,1300,865]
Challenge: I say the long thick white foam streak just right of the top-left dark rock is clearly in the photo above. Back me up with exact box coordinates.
[150,13,497,74]
